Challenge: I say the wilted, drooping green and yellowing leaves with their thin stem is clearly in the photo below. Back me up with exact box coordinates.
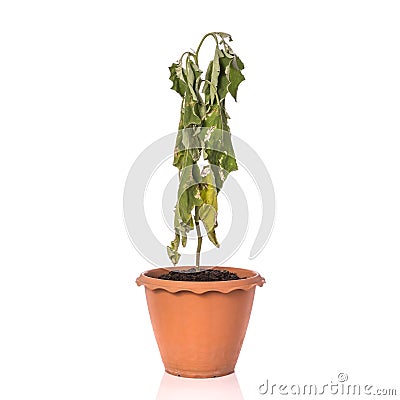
[167,32,244,266]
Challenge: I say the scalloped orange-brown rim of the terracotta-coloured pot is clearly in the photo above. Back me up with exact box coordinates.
[136,266,265,294]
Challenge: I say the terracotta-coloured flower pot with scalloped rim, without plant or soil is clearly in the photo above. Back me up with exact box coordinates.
[136,267,265,378]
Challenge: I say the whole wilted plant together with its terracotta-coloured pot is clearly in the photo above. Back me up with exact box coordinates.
[136,32,265,378]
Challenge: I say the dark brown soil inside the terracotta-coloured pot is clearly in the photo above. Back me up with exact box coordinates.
[158,268,241,282]
